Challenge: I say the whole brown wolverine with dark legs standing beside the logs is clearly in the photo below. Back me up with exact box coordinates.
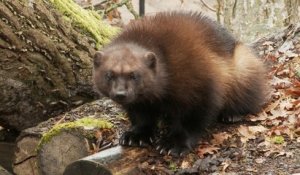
[93,12,265,155]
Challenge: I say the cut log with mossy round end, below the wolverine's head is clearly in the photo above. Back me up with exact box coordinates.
[13,99,128,175]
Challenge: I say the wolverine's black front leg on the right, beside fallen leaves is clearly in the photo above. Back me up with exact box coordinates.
[156,107,214,156]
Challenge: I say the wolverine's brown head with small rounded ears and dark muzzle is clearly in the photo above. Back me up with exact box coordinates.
[93,44,162,105]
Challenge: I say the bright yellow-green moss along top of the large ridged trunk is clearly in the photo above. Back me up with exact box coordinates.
[50,0,120,48]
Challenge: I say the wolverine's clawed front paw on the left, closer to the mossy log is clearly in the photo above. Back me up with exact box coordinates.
[119,131,153,147]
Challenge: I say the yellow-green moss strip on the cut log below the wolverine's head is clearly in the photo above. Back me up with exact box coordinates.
[37,117,113,150]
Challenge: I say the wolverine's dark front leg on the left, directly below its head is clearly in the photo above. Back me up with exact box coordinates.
[120,110,157,146]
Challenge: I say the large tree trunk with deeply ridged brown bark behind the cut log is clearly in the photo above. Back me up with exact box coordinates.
[0,0,116,130]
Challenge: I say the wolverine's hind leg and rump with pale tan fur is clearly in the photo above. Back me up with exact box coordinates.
[219,44,267,122]
